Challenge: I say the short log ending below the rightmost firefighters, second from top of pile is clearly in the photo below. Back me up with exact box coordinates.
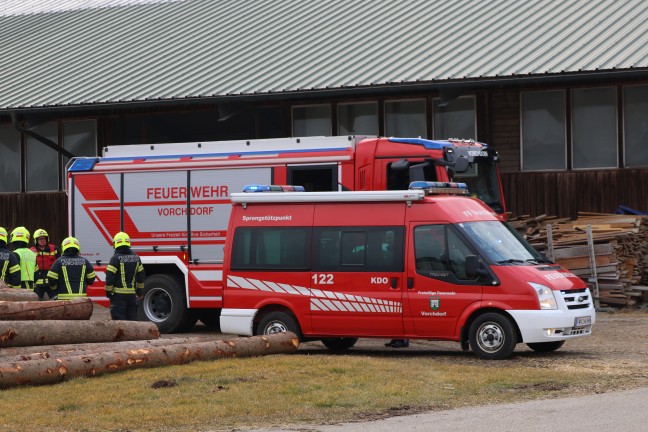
[0,298,92,321]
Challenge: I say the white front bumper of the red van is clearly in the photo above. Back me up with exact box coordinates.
[507,308,596,343]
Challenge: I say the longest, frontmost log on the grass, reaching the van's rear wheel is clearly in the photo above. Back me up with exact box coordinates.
[0,333,299,388]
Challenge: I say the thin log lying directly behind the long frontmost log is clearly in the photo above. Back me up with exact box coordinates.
[0,335,228,363]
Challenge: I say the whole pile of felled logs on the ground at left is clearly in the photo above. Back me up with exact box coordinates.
[0,281,299,388]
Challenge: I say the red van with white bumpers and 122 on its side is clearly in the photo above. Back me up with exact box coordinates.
[221,182,595,359]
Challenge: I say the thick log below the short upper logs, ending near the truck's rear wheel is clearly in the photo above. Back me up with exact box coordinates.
[0,320,160,348]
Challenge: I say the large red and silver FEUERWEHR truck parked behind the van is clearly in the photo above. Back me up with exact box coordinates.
[68,137,505,333]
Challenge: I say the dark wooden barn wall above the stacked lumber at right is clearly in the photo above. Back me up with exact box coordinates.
[501,169,648,217]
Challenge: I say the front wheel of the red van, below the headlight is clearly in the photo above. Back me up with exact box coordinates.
[469,313,517,360]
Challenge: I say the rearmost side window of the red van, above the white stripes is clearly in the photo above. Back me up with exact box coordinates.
[231,227,311,271]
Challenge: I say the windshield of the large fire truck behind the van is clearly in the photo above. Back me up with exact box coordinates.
[448,157,504,213]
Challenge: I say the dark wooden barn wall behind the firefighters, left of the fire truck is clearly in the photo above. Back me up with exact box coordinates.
[0,192,67,248]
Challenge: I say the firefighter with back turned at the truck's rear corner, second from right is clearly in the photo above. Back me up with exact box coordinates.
[47,237,96,300]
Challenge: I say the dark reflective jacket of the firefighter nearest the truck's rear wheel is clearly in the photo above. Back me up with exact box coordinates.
[106,246,144,296]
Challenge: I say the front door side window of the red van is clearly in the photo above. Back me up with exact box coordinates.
[414,225,473,280]
